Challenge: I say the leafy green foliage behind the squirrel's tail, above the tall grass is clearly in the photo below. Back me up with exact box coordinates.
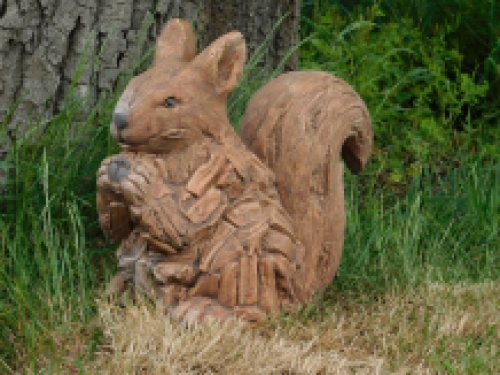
[301,1,500,189]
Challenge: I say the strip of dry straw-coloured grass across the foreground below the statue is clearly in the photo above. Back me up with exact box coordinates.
[80,282,500,374]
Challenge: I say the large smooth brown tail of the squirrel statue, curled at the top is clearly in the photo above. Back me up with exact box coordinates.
[241,71,373,297]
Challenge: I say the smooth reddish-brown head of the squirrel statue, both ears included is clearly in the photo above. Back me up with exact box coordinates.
[111,19,246,153]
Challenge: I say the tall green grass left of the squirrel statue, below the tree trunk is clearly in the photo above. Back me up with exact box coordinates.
[0,87,115,371]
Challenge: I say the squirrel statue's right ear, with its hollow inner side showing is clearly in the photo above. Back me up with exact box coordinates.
[193,31,246,96]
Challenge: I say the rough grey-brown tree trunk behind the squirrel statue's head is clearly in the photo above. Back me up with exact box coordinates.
[0,0,300,156]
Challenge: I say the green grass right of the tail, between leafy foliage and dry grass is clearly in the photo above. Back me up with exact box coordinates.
[336,156,500,291]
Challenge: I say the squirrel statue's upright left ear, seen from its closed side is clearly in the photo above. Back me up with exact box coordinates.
[154,18,196,65]
